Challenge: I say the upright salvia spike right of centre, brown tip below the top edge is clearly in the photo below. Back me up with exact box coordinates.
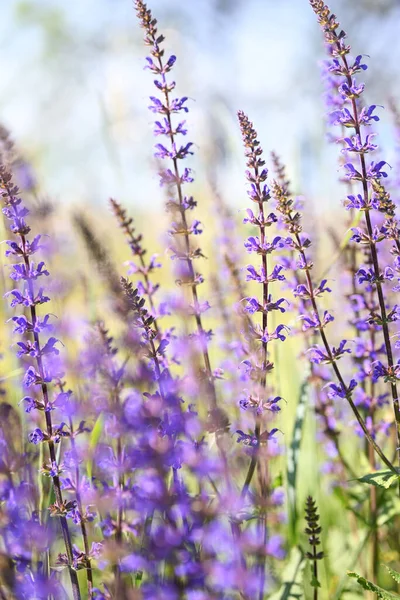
[237,111,288,598]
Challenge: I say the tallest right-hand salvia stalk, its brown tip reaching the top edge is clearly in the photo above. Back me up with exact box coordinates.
[310,0,400,478]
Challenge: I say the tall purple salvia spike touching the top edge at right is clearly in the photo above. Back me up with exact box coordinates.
[310,0,400,478]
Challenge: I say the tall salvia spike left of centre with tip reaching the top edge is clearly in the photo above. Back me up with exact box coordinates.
[135,0,222,420]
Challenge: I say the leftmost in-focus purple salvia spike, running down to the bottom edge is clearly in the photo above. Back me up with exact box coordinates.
[0,162,79,597]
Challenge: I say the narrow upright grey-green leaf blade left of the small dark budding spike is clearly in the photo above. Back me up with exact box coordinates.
[287,378,310,542]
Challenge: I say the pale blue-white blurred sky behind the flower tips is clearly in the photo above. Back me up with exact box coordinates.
[0,0,400,213]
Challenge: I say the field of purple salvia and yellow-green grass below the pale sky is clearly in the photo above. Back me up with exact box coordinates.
[0,0,400,600]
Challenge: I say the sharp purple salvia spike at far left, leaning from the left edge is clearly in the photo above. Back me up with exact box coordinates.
[0,165,81,599]
